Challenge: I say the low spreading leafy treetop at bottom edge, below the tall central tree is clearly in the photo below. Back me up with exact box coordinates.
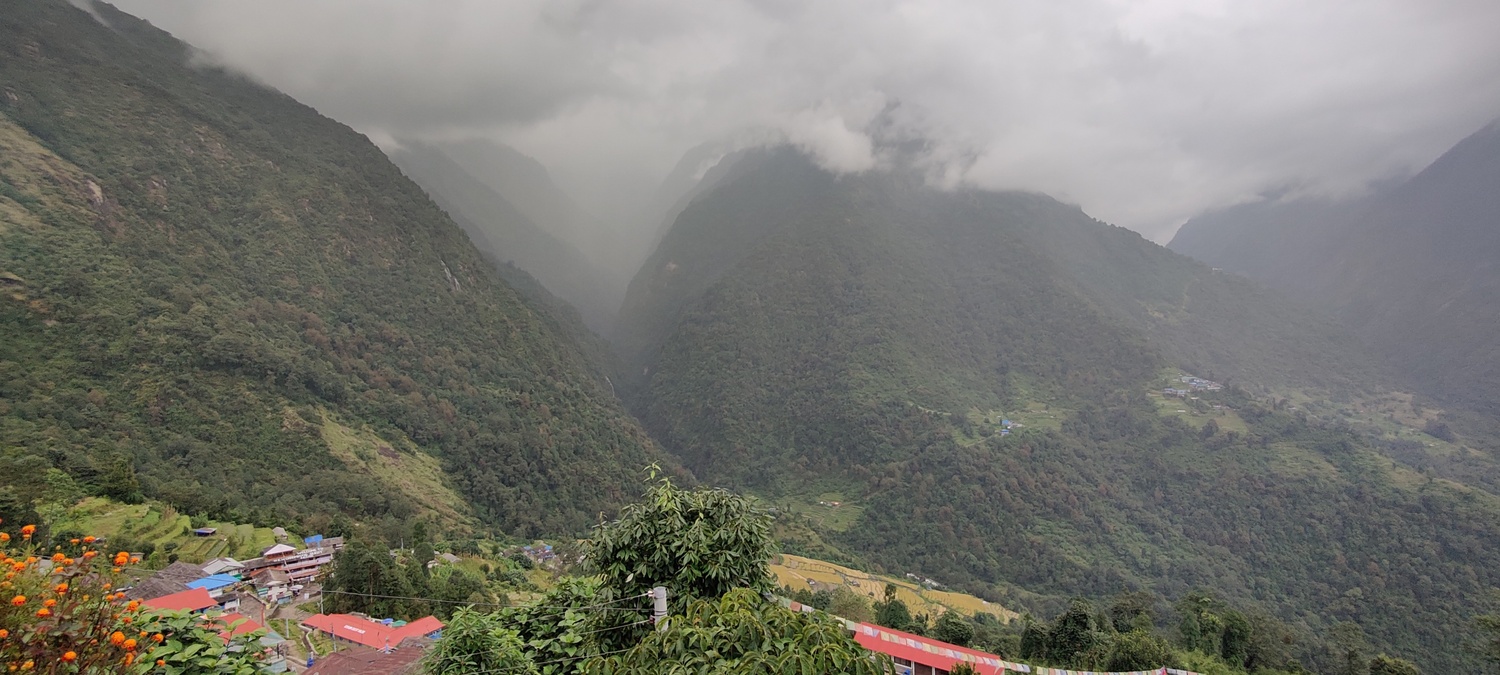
[582,588,896,675]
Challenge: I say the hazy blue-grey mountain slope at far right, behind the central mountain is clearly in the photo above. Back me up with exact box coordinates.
[1172,122,1500,419]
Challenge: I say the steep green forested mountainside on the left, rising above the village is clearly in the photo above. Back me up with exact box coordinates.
[0,0,660,533]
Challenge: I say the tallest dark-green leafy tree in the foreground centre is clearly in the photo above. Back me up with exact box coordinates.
[585,468,774,606]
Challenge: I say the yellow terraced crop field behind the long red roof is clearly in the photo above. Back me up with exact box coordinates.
[771,554,1019,620]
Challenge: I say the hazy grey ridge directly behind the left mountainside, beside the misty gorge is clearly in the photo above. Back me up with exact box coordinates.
[389,141,624,330]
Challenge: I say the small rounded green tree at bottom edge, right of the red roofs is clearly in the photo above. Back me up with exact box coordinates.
[425,608,540,675]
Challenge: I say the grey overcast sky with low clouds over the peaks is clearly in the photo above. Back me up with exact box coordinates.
[119,0,1500,242]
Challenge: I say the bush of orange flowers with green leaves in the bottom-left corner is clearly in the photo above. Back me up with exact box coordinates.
[0,525,263,675]
